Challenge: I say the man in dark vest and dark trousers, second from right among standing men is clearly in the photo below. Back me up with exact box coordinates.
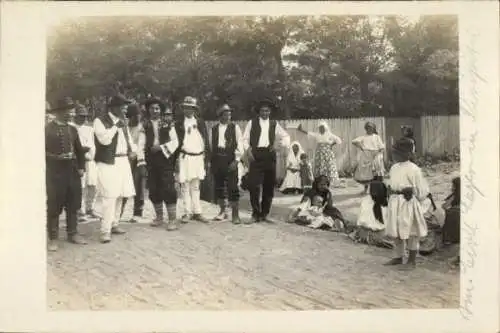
[211,104,243,224]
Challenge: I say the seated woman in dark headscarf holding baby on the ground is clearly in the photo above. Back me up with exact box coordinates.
[288,176,345,231]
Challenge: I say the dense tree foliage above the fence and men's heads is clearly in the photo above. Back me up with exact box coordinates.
[47,16,458,119]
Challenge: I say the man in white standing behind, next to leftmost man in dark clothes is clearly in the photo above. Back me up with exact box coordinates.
[74,104,97,217]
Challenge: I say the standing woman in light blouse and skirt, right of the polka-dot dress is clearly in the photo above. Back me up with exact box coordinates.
[352,122,385,193]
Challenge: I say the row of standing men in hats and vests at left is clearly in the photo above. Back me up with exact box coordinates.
[45,94,290,251]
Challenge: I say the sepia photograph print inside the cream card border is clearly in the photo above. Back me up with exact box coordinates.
[45,15,461,311]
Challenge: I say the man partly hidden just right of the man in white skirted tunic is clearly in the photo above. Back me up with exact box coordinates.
[120,103,146,223]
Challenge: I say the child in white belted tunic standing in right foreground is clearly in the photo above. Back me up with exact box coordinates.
[385,138,429,270]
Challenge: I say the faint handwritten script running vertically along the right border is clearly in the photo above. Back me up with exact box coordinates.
[460,29,486,320]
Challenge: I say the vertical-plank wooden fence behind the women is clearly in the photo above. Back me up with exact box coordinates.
[207,116,460,178]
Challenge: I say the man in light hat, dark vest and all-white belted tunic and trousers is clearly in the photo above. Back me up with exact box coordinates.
[175,96,210,223]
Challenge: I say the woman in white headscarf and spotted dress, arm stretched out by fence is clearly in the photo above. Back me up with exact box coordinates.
[297,120,342,186]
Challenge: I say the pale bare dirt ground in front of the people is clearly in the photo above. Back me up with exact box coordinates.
[47,165,459,310]
